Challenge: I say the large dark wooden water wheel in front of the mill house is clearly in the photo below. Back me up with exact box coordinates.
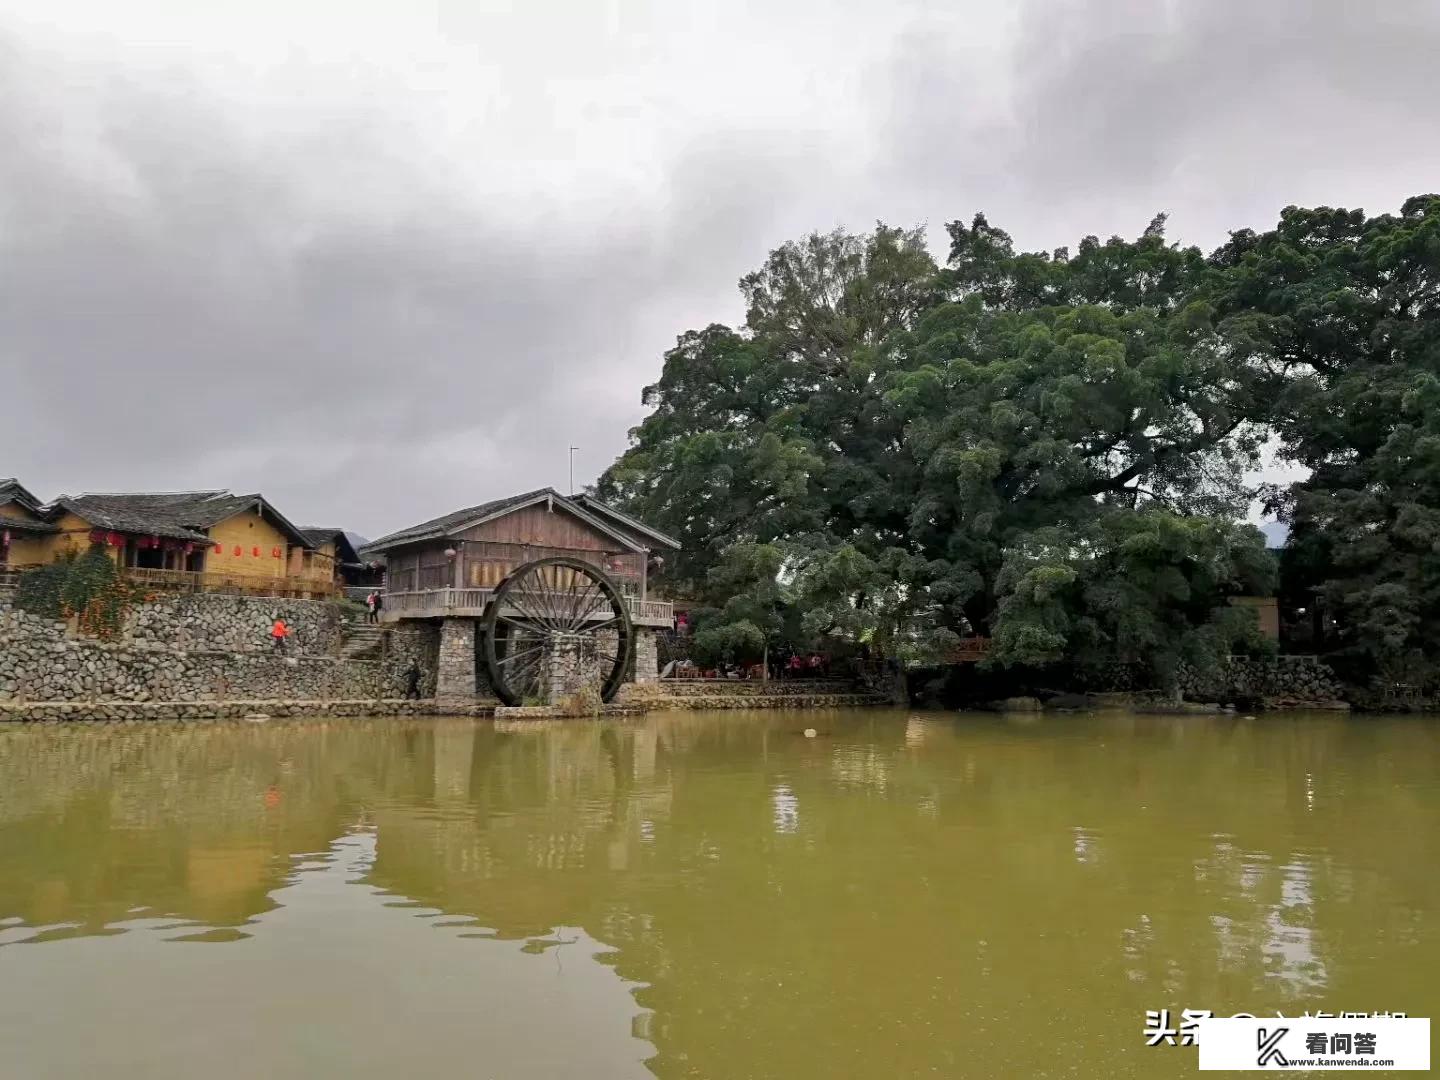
[484,557,635,706]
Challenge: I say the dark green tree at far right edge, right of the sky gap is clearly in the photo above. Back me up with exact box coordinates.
[1214,194,1440,683]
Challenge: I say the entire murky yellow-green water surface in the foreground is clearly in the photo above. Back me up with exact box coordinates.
[0,711,1440,1080]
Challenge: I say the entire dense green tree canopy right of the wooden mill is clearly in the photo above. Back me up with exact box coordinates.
[599,197,1440,694]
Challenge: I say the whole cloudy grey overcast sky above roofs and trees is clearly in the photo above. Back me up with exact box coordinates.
[0,0,1440,536]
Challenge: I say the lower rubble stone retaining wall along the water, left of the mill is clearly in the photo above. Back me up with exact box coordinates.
[0,613,433,703]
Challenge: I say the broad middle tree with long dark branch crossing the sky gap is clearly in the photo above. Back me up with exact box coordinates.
[887,210,1269,636]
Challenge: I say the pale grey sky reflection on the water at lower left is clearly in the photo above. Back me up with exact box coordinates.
[0,831,651,1080]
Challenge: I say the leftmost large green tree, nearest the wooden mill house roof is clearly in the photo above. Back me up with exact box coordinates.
[598,228,936,590]
